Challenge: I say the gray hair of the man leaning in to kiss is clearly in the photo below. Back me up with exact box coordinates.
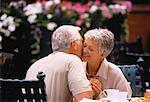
[51,25,81,51]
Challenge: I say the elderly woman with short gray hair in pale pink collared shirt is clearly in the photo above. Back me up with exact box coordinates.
[82,28,132,97]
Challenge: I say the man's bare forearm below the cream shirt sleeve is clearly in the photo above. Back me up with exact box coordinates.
[74,91,93,102]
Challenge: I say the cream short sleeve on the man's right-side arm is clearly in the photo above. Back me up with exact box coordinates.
[68,58,92,96]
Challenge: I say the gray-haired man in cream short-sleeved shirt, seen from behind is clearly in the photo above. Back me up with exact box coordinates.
[25,25,93,102]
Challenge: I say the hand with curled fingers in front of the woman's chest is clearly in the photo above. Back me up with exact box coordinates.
[90,78,102,98]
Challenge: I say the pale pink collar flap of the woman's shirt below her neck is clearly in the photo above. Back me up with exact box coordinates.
[96,58,108,80]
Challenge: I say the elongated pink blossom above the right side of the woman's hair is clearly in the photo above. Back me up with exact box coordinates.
[101,4,112,19]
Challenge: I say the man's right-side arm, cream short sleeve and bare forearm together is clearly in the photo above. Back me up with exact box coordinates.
[68,58,93,102]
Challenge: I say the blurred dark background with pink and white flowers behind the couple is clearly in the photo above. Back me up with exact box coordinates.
[0,0,150,96]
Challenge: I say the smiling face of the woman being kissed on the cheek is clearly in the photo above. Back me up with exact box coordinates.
[82,38,101,63]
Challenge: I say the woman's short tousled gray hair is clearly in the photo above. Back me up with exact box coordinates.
[84,28,114,57]
